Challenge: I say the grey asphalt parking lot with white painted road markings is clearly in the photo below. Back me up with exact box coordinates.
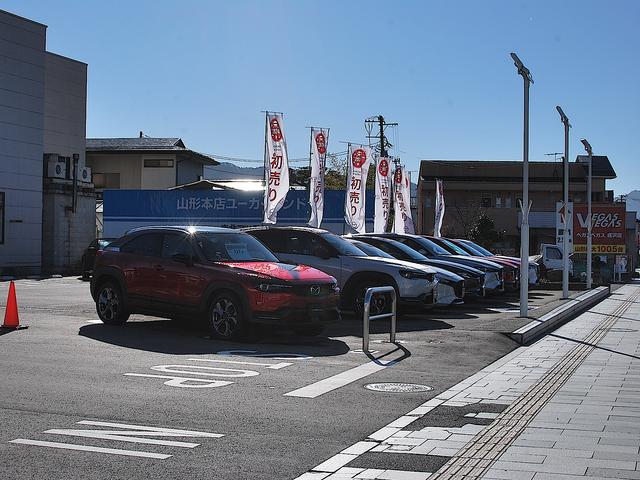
[0,277,560,479]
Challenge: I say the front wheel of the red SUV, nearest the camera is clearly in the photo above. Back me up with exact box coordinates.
[207,290,249,340]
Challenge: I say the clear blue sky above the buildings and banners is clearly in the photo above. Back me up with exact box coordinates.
[6,0,640,195]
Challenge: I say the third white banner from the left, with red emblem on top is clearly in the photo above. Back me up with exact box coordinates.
[344,144,371,233]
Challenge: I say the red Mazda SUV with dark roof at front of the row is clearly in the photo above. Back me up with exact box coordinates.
[91,227,340,340]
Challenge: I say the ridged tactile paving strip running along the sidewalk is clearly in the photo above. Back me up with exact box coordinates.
[429,292,640,480]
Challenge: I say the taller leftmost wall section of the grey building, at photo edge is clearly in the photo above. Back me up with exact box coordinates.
[0,10,47,273]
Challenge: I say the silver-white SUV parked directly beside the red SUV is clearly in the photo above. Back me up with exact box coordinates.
[243,226,438,315]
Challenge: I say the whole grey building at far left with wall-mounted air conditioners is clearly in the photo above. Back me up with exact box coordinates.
[0,10,95,275]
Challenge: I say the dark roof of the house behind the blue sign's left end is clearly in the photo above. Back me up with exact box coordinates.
[87,137,219,165]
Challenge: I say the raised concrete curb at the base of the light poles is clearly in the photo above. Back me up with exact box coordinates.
[508,286,611,345]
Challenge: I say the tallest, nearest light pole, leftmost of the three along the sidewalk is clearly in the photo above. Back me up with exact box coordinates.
[511,52,533,317]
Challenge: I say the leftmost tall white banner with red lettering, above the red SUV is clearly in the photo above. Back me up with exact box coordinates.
[264,113,289,223]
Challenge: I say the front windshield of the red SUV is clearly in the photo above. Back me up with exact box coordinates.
[196,232,278,262]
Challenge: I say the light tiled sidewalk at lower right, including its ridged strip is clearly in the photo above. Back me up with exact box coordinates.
[299,284,640,480]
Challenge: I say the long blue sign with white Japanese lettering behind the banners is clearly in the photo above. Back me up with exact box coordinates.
[103,190,374,237]
